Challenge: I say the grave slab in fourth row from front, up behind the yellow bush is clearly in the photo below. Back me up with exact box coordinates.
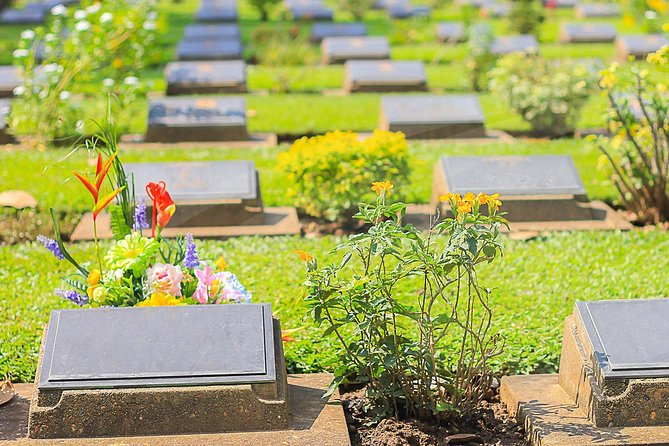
[344,60,427,93]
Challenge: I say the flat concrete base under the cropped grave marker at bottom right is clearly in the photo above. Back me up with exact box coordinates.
[500,375,669,446]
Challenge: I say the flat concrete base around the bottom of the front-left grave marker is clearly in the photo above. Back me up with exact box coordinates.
[0,373,350,446]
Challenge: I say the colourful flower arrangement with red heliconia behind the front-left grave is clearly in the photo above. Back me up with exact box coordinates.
[38,116,251,307]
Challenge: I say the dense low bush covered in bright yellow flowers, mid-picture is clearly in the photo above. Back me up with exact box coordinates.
[279,130,409,221]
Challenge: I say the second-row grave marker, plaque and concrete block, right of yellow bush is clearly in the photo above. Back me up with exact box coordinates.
[432,155,594,223]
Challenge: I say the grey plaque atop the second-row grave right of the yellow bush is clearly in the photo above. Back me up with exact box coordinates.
[441,155,586,196]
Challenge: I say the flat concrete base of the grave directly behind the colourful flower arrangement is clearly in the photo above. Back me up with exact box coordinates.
[70,207,302,241]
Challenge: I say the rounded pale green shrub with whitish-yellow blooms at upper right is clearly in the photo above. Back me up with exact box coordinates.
[489,54,596,136]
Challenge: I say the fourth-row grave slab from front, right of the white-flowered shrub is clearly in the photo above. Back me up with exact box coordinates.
[165,60,246,96]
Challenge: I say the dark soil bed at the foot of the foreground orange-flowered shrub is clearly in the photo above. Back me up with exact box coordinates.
[342,389,527,446]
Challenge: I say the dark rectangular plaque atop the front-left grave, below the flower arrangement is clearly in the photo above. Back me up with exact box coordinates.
[39,304,276,389]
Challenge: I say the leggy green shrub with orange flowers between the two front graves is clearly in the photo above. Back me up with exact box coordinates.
[298,181,506,420]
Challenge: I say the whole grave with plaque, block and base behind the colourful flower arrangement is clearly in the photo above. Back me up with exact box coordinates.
[72,161,300,240]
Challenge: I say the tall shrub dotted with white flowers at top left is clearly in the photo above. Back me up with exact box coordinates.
[11,0,156,141]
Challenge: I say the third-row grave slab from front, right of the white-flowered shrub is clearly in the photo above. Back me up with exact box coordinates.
[146,97,248,142]
